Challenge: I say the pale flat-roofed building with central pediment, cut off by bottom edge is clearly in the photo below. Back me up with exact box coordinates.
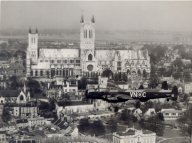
[113,128,156,143]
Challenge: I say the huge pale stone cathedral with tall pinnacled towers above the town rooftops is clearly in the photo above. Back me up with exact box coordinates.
[26,16,151,78]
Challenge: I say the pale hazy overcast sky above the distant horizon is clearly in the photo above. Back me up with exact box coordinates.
[1,1,192,32]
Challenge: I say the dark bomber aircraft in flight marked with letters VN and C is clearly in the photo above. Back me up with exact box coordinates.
[85,86,178,102]
